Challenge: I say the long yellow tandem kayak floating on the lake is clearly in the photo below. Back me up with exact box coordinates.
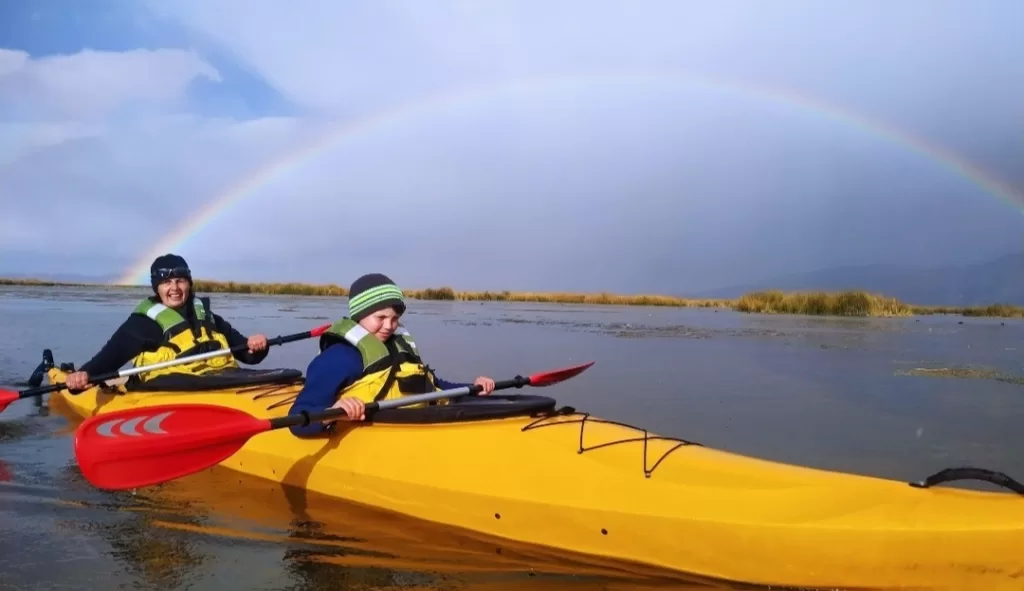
[48,368,1024,591]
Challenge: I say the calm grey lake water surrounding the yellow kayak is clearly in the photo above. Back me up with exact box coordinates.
[0,287,1024,591]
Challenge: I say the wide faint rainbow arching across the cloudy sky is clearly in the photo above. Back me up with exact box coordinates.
[116,69,1024,285]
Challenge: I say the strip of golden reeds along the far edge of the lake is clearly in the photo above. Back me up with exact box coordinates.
[0,278,1024,318]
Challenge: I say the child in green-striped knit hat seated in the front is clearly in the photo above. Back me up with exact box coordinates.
[289,273,495,435]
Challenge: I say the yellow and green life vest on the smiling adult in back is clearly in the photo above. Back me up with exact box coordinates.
[132,297,239,382]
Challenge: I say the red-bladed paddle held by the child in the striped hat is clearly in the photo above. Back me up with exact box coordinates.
[75,362,594,491]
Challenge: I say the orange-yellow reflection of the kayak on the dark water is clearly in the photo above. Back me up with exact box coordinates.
[132,468,739,591]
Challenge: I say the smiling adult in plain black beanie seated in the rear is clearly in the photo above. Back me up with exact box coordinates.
[66,254,267,391]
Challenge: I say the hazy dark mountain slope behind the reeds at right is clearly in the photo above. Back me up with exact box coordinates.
[690,254,1024,306]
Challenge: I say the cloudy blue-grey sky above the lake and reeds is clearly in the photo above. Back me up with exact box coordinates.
[0,0,1024,294]
